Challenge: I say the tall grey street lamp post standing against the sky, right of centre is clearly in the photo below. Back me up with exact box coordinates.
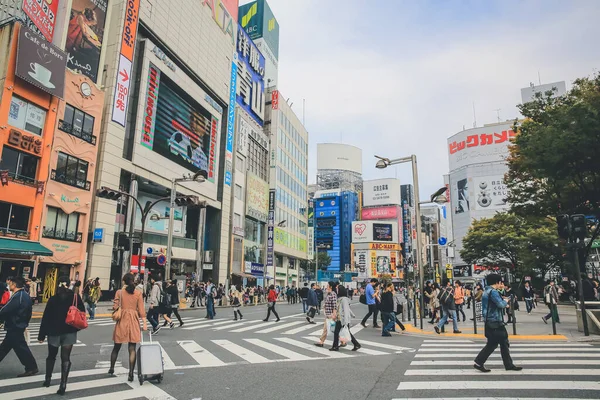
[375,154,446,329]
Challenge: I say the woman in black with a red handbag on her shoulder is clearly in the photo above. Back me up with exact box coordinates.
[38,276,87,395]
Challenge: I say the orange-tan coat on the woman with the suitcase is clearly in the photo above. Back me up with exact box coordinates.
[113,289,146,343]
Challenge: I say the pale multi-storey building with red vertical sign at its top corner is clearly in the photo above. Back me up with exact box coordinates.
[265,89,308,286]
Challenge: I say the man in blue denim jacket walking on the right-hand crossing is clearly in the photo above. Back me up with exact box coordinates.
[473,274,523,372]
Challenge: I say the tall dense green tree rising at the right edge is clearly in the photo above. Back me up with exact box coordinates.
[506,74,600,254]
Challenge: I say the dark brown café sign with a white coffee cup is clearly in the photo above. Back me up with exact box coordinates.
[15,26,67,99]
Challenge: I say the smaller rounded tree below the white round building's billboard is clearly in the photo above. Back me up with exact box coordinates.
[460,212,563,278]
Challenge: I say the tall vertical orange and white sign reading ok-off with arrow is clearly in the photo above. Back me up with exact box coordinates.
[112,0,140,127]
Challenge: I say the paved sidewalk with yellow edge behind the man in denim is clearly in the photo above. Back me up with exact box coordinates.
[398,302,600,342]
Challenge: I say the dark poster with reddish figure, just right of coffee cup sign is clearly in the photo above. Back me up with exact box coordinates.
[66,0,108,82]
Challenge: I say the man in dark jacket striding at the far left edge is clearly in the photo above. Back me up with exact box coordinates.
[0,276,39,378]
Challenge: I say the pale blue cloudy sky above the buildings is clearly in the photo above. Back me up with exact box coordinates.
[240,0,600,199]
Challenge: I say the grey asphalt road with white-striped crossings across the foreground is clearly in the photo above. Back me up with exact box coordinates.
[0,304,600,400]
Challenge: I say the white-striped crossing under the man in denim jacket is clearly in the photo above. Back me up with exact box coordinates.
[394,340,600,400]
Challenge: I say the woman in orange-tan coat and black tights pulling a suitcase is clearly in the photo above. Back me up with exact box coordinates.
[108,273,148,382]
